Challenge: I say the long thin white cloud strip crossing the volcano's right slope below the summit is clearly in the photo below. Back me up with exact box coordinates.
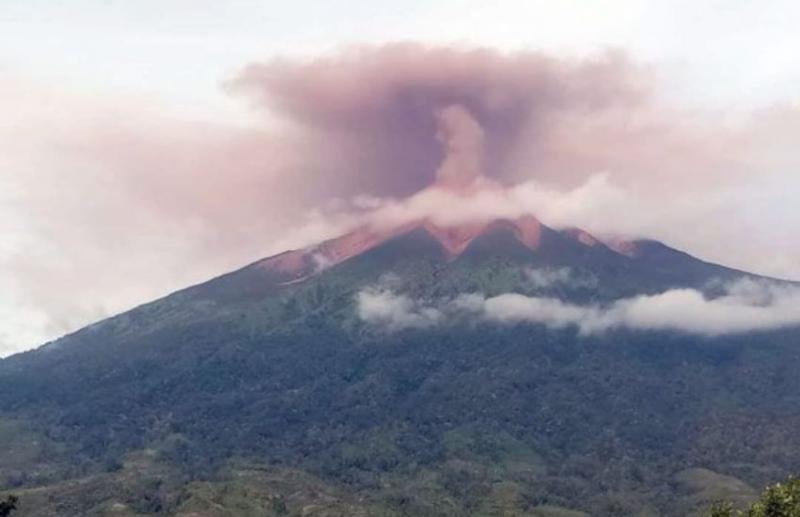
[356,279,800,336]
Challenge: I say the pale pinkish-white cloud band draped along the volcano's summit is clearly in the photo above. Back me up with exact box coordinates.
[301,173,730,246]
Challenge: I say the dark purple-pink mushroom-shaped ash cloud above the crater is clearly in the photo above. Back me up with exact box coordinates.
[229,43,649,196]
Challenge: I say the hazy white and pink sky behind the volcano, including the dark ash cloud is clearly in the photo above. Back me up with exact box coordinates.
[0,0,800,356]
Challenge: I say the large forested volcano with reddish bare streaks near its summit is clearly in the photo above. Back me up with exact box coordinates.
[0,216,800,516]
